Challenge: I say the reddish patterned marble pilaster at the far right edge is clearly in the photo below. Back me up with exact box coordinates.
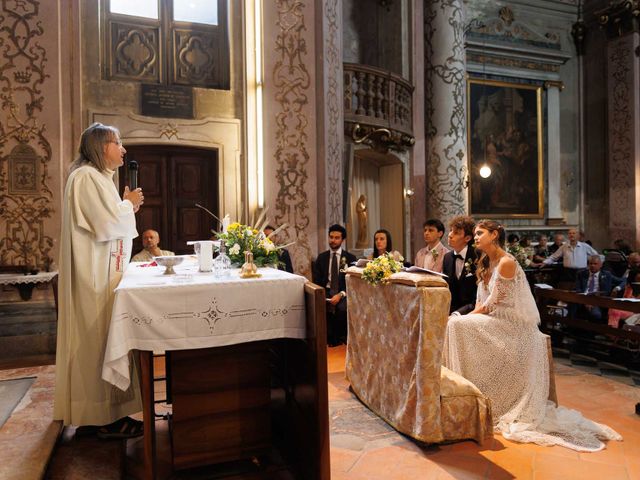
[607,32,640,247]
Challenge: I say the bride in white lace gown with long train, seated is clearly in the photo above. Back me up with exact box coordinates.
[443,220,622,452]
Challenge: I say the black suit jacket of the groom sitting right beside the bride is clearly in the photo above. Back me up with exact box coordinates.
[442,246,478,315]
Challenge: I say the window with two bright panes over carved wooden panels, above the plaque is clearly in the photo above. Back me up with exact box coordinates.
[103,0,229,90]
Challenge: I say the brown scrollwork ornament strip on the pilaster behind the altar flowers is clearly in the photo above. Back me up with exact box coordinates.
[272,0,312,276]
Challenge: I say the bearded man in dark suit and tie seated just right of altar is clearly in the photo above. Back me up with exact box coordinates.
[313,225,356,347]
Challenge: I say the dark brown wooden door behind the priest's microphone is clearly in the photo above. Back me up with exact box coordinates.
[120,145,218,254]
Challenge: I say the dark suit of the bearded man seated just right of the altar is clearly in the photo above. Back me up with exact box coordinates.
[313,248,356,345]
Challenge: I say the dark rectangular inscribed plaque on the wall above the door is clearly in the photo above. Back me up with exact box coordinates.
[140,84,193,118]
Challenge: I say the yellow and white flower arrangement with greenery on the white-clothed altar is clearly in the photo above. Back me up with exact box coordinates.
[196,204,293,268]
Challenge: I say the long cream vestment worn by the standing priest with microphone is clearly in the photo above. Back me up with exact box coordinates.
[53,166,142,425]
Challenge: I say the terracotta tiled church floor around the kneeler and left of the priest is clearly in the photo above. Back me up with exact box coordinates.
[0,347,640,480]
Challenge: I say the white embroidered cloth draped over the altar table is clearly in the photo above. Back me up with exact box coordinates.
[102,257,306,390]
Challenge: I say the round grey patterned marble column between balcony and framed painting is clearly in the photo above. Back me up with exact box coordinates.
[424,0,469,224]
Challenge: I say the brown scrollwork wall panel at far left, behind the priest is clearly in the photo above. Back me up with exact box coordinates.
[0,0,53,268]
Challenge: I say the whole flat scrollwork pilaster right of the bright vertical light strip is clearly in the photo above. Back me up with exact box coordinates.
[263,0,318,277]
